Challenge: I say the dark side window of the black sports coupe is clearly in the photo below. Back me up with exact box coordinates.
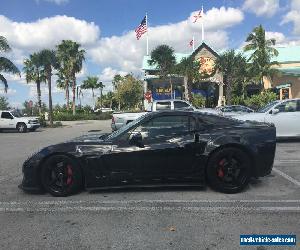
[133,115,196,139]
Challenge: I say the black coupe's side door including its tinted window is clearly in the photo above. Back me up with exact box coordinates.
[127,114,200,183]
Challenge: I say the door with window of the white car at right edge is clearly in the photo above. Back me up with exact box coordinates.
[265,100,300,137]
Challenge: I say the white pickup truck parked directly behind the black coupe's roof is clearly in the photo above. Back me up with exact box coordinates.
[111,99,219,131]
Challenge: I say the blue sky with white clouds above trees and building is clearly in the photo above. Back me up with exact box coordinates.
[0,0,300,108]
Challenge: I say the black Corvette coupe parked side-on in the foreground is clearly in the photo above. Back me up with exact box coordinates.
[20,111,276,196]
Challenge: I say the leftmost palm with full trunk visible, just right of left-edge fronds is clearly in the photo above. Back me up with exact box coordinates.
[23,53,46,114]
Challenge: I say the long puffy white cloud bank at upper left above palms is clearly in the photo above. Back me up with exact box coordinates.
[0,15,100,52]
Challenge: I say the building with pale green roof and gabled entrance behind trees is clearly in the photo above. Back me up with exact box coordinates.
[142,43,300,106]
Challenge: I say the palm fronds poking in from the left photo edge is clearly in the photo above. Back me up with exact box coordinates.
[0,36,21,93]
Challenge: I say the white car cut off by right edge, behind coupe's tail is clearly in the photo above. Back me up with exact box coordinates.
[234,98,300,138]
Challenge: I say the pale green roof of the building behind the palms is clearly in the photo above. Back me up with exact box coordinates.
[142,44,300,72]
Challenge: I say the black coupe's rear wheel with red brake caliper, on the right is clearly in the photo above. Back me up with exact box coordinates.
[206,147,251,194]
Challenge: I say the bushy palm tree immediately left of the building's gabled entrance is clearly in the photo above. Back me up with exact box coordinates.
[175,56,201,101]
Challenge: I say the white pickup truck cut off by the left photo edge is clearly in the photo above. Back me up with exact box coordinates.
[0,110,40,133]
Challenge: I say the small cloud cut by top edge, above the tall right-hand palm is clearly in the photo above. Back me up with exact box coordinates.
[243,0,279,17]
